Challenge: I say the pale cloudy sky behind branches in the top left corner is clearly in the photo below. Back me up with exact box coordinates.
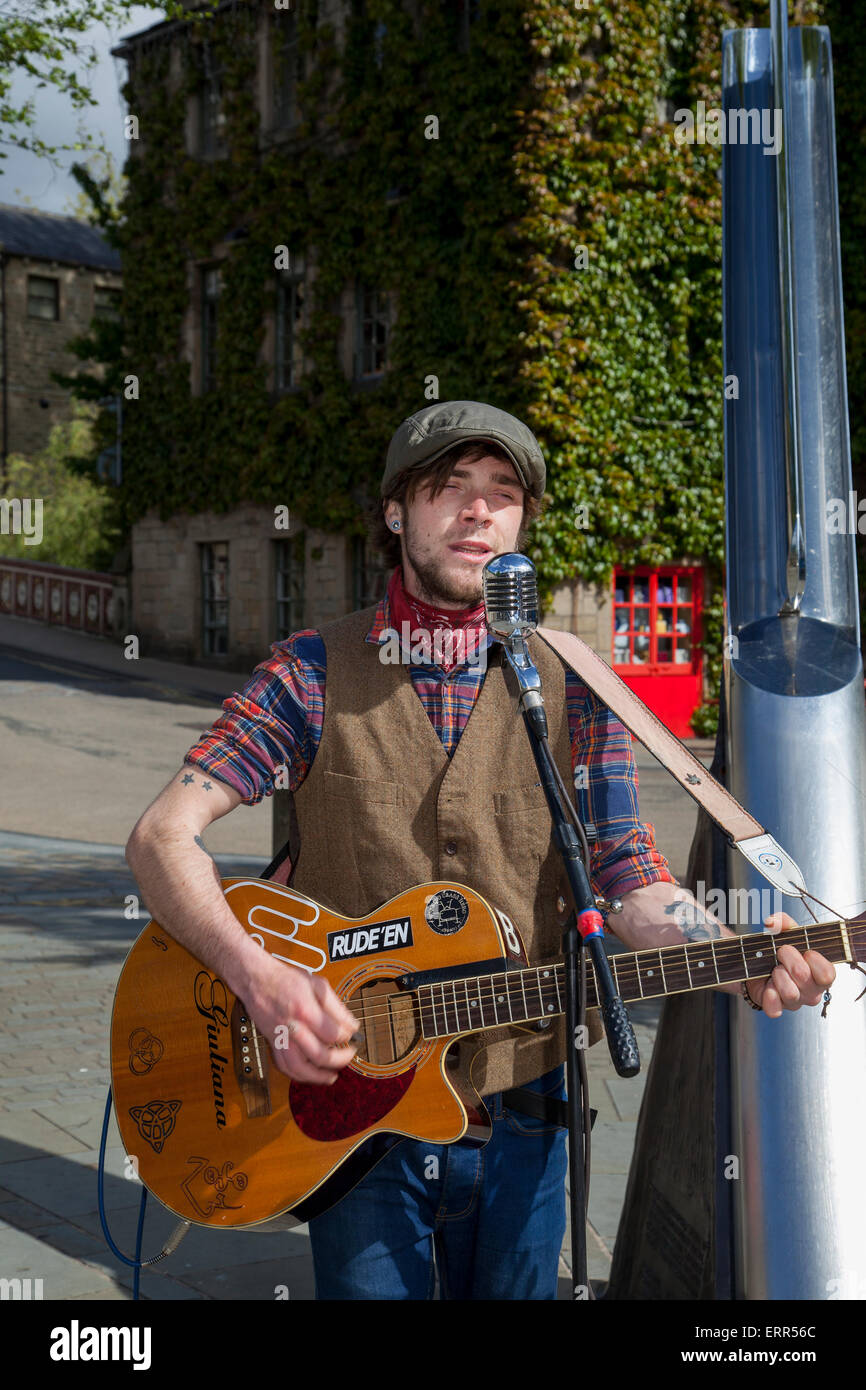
[0,6,164,213]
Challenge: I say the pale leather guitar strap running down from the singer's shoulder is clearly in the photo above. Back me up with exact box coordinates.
[537,627,803,897]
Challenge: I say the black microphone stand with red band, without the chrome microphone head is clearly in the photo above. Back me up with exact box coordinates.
[500,628,641,1300]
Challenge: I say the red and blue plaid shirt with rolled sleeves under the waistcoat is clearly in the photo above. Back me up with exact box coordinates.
[185,596,676,898]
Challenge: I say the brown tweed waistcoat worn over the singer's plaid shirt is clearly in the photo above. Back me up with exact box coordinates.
[292,609,599,1095]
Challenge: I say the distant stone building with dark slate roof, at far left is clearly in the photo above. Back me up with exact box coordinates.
[0,204,122,459]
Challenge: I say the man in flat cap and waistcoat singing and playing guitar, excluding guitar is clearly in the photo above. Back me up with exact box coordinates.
[126,402,835,1300]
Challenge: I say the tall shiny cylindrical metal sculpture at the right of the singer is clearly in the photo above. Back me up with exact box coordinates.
[723,21,866,1300]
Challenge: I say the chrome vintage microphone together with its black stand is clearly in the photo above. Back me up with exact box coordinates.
[481,553,641,1298]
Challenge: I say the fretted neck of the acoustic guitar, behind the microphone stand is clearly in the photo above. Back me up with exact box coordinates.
[416,922,866,1038]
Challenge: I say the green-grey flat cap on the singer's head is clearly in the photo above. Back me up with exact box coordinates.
[381,400,546,498]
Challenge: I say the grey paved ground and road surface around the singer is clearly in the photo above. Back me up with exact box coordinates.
[0,619,712,1301]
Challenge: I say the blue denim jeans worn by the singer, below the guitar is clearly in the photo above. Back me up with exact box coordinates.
[310,1066,567,1300]
